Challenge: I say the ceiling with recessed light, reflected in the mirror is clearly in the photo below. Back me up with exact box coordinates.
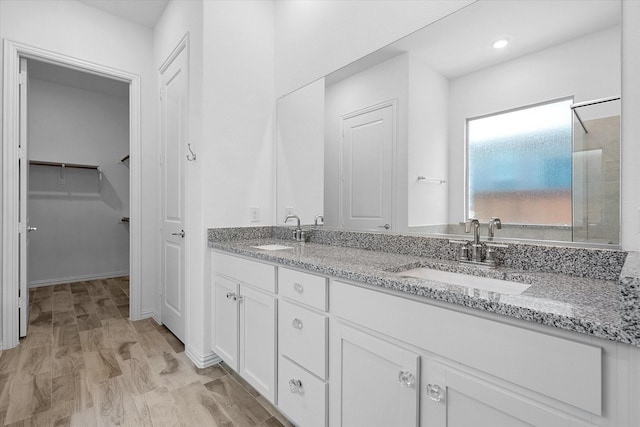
[327,0,621,84]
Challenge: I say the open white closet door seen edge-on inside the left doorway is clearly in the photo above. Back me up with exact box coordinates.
[18,58,35,337]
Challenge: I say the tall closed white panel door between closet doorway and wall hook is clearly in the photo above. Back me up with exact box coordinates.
[160,47,189,341]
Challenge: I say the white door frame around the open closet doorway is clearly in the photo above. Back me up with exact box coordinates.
[0,39,142,349]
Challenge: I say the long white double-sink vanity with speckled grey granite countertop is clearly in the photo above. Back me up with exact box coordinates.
[209,227,640,426]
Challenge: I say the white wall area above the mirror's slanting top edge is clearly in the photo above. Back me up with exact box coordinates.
[275,0,473,96]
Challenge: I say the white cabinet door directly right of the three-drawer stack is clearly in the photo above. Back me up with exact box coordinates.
[329,322,420,427]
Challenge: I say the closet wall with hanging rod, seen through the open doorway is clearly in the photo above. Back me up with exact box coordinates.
[28,79,129,285]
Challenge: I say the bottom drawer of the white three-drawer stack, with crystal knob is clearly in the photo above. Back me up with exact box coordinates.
[278,356,328,427]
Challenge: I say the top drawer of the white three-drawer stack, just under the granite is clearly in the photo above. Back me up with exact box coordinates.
[278,267,327,311]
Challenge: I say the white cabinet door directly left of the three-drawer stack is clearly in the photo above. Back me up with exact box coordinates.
[238,286,276,402]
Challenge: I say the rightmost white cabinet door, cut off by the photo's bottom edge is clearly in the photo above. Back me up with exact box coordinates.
[421,362,586,427]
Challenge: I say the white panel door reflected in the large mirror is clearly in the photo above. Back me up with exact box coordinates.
[341,104,395,231]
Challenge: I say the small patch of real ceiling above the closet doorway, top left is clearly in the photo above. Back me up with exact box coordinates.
[80,0,169,28]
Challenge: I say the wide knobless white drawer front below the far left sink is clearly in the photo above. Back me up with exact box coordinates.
[213,252,276,293]
